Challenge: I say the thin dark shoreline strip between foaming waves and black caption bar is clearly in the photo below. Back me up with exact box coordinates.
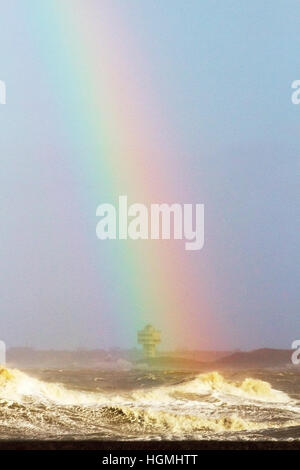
[0,440,300,451]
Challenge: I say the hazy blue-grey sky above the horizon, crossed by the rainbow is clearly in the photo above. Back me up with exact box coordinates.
[0,0,300,349]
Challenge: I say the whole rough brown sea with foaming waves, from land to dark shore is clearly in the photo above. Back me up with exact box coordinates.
[0,369,300,440]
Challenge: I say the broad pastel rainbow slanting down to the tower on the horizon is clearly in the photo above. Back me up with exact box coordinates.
[26,0,215,347]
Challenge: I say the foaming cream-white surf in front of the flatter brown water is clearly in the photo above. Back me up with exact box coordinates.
[0,368,300,439]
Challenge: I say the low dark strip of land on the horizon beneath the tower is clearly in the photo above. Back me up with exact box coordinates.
[7,348,292,370]
